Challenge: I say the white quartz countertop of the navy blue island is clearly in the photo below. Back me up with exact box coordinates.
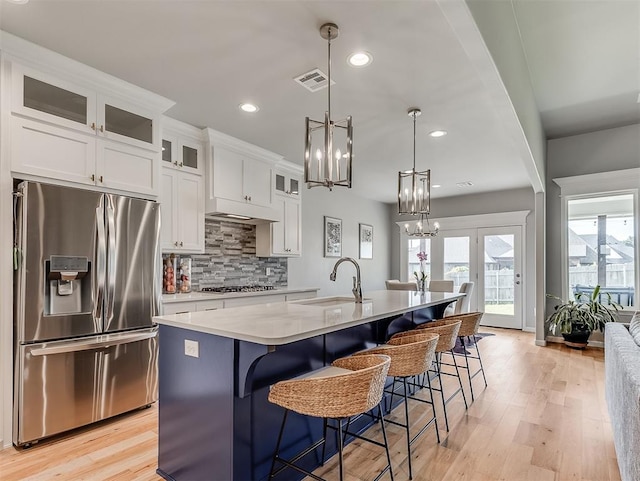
[153,290,465,345]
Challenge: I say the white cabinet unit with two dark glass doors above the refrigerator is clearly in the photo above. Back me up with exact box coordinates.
[5,55,172,198]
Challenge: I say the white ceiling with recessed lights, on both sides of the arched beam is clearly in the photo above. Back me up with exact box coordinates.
[0,0,640,202]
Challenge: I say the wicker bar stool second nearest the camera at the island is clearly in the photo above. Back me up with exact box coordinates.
[353,333,440,479]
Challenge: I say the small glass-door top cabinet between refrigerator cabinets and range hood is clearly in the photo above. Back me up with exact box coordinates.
[162,116,204,175]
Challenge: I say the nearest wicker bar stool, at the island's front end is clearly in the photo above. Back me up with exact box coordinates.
[269,354,393,481]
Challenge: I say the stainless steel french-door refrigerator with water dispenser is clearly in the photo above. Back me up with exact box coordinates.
[13,182,161,445]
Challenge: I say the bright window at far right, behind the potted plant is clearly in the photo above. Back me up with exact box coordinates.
[567,193,638,307]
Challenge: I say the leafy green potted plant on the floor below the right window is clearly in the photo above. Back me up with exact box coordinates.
[547,285,622,349]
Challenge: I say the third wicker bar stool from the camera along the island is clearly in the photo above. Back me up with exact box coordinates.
[392,319,469,432]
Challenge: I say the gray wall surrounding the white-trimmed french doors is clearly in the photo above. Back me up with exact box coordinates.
[388,188,536,330]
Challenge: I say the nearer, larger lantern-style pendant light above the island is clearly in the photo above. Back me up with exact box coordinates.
[304,23,353,190]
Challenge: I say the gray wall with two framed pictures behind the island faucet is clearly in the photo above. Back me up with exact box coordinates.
[289,187,391,296]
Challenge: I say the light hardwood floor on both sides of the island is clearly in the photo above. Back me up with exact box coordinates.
[0,328,620,481]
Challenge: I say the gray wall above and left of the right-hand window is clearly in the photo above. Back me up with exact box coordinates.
[546,124,640,313]
